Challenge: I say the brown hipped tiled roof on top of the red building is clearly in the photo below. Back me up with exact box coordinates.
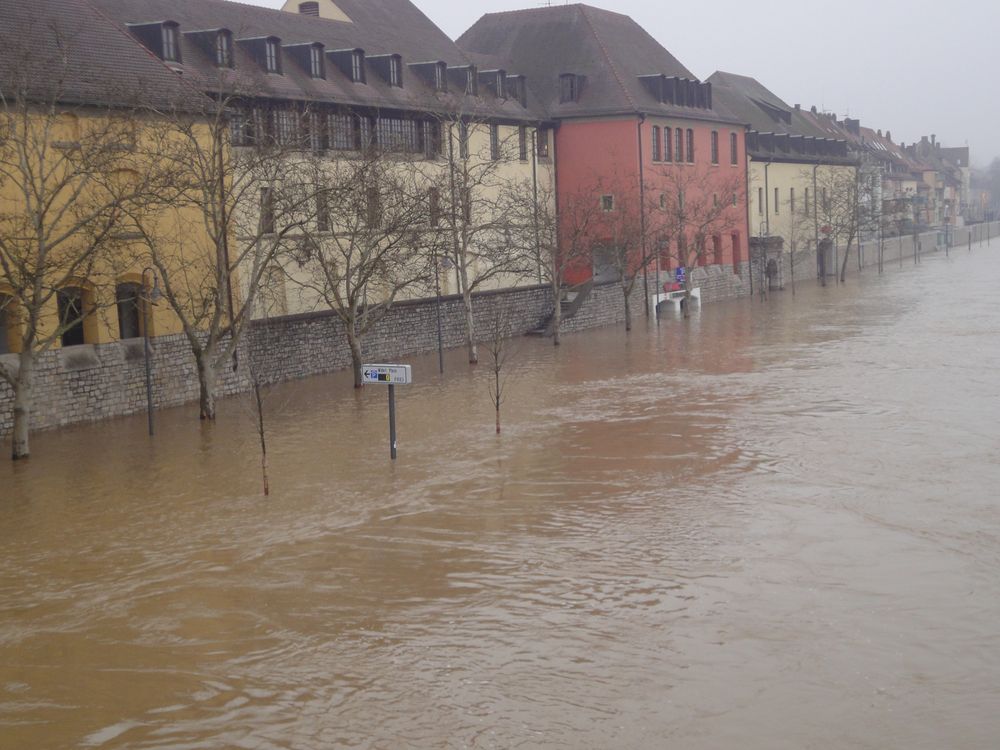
[458,4,733,122]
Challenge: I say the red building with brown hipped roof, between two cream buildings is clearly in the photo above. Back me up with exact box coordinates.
[458,5,749,288]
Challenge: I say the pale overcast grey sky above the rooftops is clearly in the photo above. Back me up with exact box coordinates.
[253,0,1000,165]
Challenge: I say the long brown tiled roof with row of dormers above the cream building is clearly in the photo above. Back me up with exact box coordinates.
[91,0,541,119]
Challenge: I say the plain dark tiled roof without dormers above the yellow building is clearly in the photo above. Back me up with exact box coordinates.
[0,0,201,106]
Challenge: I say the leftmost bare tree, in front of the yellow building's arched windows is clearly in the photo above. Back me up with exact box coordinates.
[0,47,158,459]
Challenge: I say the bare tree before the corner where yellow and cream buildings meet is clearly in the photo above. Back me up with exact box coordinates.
[136,90,308,420]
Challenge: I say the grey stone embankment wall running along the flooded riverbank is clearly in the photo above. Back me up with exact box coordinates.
[0,223,1000,436]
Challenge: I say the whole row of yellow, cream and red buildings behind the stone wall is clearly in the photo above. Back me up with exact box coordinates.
[0,0,977,452]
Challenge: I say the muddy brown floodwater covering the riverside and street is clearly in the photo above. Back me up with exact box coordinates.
[0,245,1000,750]
